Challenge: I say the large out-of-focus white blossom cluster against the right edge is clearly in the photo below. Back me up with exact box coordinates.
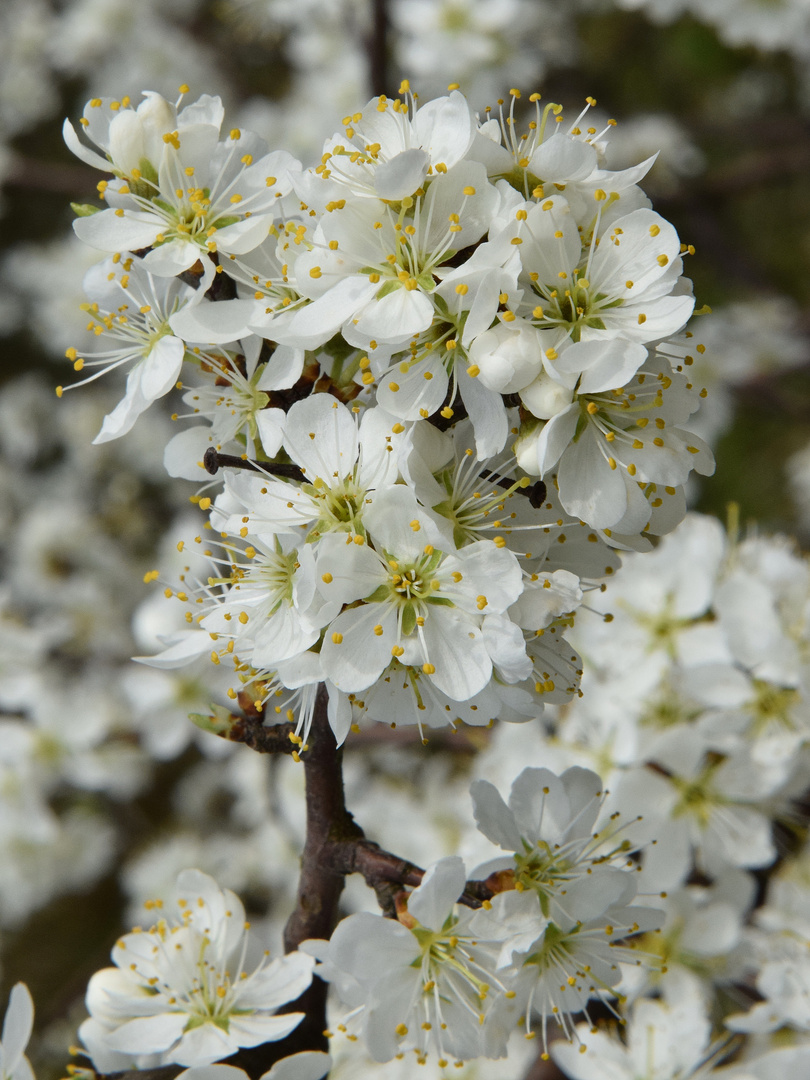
[556,514,810,898]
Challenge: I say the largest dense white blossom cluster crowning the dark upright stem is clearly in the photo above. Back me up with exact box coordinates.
[59,84,714,742]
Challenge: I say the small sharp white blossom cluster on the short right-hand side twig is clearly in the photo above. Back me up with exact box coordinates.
[319,768,660,1066]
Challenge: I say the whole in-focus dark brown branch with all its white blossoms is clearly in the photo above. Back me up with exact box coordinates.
[49,79,756,1080]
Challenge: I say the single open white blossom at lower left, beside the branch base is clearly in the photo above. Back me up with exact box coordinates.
[80,870,312,1068]
